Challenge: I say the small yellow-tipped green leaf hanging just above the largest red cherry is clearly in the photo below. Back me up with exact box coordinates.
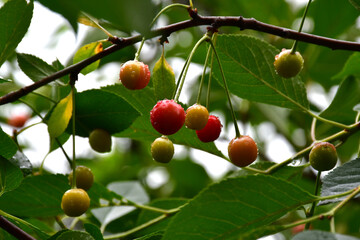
[152,51,175,100]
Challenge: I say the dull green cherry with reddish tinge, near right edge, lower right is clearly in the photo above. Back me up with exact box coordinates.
[309,142,337,171]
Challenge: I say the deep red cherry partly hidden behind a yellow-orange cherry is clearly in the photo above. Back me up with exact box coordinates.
[196,115,222,142]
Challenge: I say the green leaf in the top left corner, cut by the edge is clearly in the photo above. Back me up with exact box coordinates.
[0,0,34,66]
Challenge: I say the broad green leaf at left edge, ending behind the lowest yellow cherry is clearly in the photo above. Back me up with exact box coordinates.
[0,175,70,217]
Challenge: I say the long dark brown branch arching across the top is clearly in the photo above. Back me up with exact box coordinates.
[0,14,360,105]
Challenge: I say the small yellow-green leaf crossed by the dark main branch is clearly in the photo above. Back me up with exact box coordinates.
[73,42,103,75]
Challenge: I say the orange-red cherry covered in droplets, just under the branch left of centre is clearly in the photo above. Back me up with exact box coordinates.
[120,60,150,90]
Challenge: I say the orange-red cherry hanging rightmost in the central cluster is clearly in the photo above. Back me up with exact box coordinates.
[228,136,258,167]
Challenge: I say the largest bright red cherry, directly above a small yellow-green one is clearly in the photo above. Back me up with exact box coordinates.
[150,99,185,135]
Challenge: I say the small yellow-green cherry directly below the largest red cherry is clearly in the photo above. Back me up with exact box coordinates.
[151,136,174,163]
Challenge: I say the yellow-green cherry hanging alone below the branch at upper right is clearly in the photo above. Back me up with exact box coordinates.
[274,49,304,78]
